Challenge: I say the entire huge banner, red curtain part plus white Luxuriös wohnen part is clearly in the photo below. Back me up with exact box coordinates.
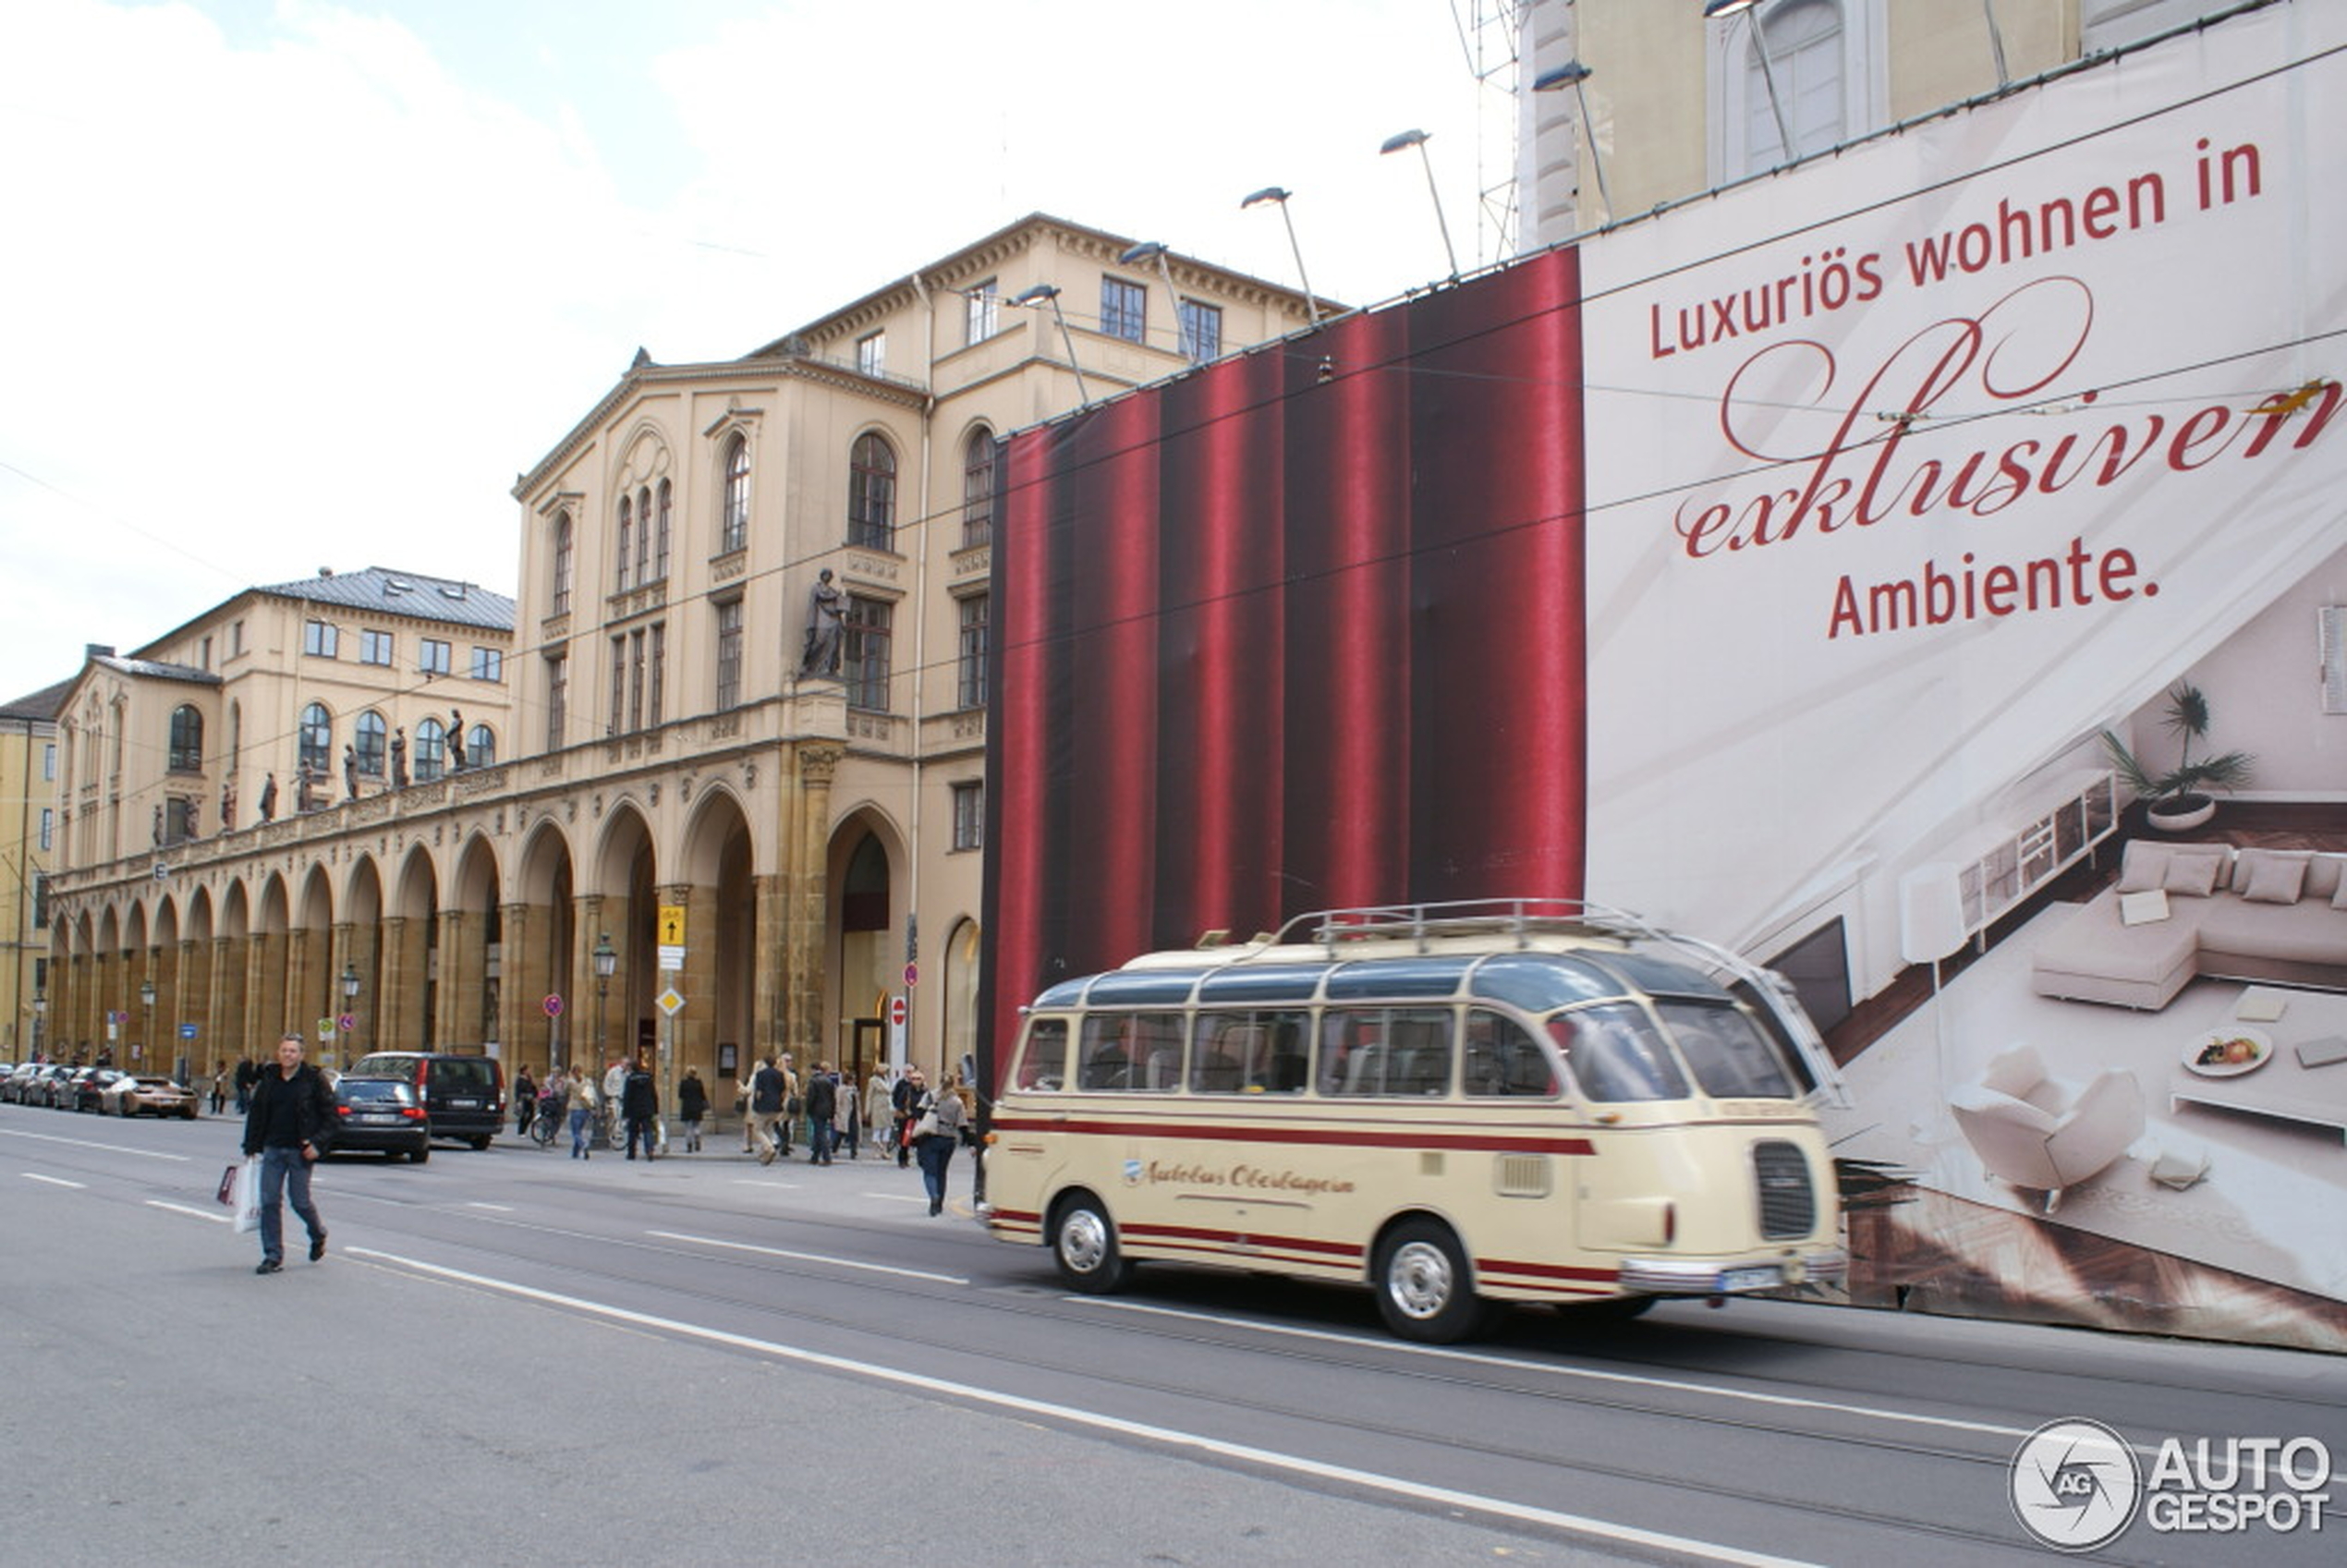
[981,5,2347,1350]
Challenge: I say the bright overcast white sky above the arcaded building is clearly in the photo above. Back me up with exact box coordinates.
[0,0,1512,698]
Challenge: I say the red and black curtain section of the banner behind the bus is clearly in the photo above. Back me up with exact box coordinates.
[983,253,1582,1065]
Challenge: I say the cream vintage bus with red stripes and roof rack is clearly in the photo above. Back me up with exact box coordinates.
[986,899,1847,1343]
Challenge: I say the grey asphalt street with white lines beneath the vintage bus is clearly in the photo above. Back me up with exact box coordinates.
[0,1106,2347,1568]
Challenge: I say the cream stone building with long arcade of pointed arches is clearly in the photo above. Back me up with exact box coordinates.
[52,213,1326,1103]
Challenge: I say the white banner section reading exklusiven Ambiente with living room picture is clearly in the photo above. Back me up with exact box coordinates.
[1582,5,2347,1347]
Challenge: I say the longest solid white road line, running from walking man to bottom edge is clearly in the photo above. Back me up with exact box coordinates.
[345,1233,1798,1568]
